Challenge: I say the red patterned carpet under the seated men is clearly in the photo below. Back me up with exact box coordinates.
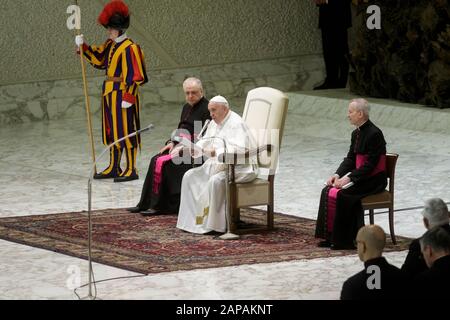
[0,209,410,274]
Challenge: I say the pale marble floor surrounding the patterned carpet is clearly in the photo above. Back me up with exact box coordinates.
[0,90,450,300]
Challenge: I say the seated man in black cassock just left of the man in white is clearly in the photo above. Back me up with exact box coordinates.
[128,78,211,214]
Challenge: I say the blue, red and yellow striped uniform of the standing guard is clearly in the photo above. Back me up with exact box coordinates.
[83,38,148,176]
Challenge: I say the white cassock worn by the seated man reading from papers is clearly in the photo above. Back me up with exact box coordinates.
[177,110,258,233]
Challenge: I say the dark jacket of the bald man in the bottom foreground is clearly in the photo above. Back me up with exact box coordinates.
[341,257,405,300]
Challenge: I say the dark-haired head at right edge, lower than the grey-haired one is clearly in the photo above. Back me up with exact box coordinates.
[420,226,450,268]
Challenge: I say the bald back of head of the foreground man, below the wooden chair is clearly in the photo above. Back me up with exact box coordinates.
[356,224,386,261]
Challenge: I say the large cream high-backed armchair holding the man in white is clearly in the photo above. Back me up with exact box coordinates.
[221,87,289,233]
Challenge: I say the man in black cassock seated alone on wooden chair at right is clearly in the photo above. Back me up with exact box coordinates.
[315,99,387,249]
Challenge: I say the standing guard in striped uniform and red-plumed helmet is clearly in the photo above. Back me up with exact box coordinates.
[75,0,148,182]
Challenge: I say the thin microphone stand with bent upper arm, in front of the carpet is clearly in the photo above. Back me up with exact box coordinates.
[81,124,154,300]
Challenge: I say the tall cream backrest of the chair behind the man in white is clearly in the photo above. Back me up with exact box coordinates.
[242,87,289,174]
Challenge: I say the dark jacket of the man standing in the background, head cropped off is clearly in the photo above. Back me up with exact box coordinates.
[319,0,352,29]
